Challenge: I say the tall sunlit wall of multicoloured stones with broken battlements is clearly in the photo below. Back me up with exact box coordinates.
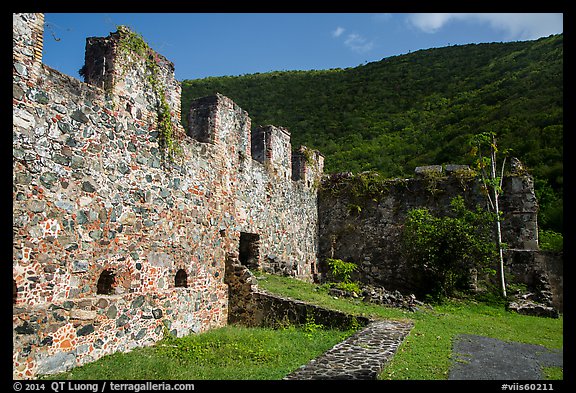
[13,14,323,379]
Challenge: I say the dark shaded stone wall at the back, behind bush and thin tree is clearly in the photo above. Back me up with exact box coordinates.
[318,165,563,311]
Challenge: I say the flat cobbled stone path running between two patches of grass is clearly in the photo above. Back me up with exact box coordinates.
[284,321,413,380]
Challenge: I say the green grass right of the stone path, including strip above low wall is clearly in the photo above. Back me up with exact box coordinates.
[259,275,563,380]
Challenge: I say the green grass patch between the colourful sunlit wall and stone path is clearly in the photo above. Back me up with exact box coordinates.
[42,325,353,380]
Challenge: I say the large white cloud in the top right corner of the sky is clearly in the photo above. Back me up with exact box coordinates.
[408,13,563,40]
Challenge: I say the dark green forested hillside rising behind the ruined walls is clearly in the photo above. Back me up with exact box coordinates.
[182,34,563,231]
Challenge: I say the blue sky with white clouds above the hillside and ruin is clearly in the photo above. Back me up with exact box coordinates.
[43,13,563,81]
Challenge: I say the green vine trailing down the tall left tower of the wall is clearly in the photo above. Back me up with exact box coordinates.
[117,26,180,159]
